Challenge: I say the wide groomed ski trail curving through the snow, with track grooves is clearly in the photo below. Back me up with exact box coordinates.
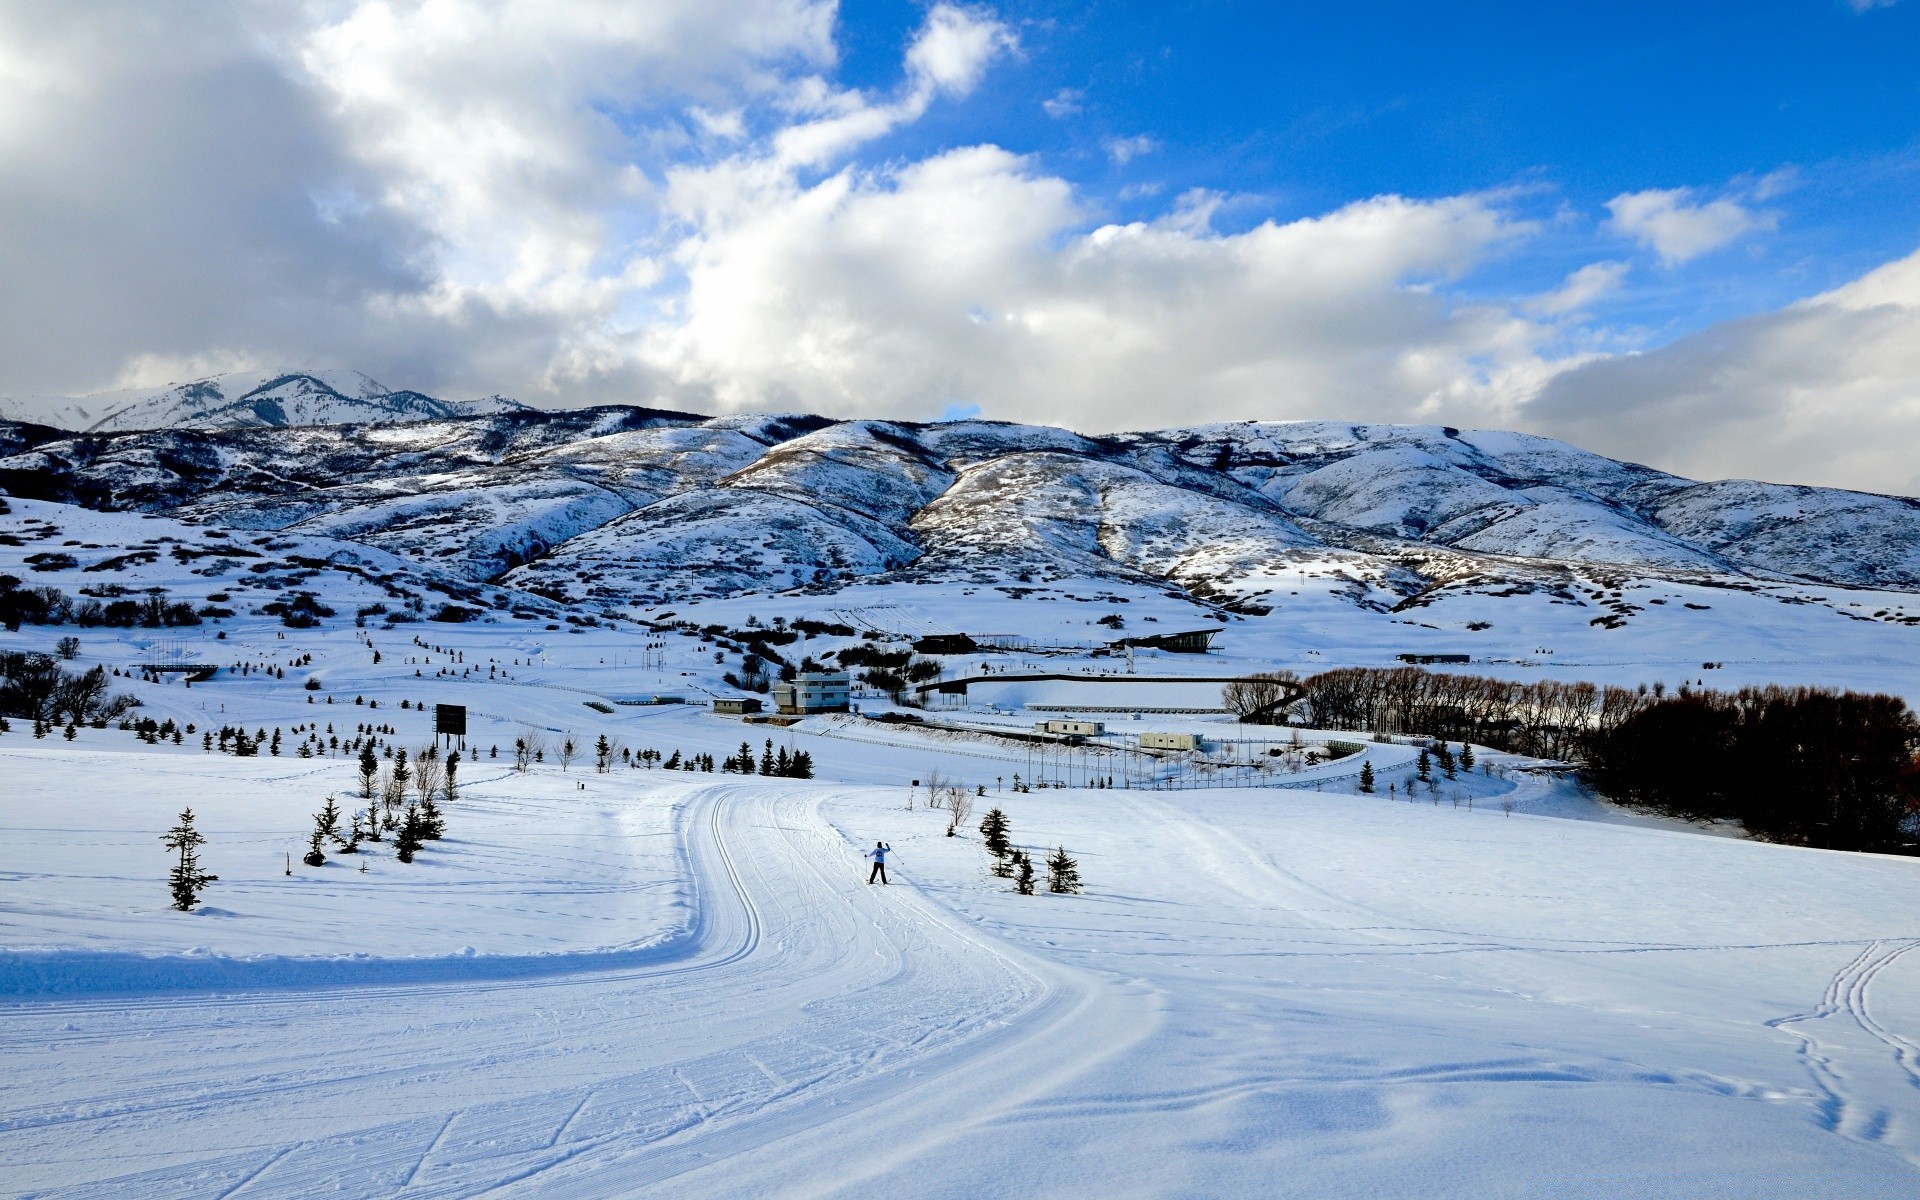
[0,783,1150,1198]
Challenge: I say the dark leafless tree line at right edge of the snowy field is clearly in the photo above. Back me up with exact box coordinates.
[1244,666,1920,854]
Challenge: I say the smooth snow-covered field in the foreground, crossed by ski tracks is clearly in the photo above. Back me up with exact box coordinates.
[0,620,1920,1198]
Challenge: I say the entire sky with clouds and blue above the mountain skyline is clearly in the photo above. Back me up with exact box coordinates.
[0,0,1920,493]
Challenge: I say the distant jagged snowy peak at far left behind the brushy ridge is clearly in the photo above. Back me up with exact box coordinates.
[0,371,524,432]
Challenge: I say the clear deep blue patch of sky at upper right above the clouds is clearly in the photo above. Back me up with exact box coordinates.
[839,0,1920,342]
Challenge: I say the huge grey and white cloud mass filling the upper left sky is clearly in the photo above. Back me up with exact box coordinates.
[0,0,833,394]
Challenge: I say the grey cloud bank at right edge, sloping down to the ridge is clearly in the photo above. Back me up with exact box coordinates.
[1524,245,1920,495]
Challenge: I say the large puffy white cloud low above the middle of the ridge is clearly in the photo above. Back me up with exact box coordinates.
[643,146,1538,428]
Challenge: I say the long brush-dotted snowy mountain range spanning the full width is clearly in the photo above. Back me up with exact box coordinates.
[0,405,1920,612]
